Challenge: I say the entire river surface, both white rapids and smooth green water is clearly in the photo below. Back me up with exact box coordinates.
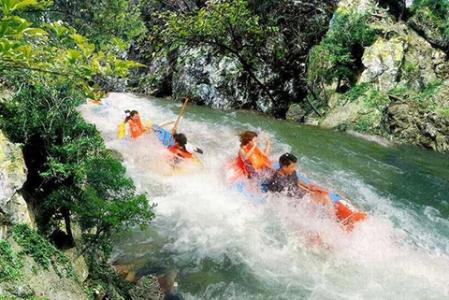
[82,94,449,299]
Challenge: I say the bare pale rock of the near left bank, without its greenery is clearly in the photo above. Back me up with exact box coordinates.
[0,131,88,300]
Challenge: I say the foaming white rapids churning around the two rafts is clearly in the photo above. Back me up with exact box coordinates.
[80,94,449,299]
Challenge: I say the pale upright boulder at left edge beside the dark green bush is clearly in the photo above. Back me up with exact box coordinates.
[0,131,33,238]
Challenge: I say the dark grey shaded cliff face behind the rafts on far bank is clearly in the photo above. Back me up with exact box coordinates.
[131,0,335,117]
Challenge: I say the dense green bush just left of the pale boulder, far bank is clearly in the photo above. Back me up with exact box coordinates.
[308,12,376,85]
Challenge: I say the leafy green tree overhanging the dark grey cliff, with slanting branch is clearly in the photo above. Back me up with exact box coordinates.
[154,0,283,102]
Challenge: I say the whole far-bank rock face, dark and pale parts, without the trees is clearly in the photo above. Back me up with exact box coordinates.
[134,0,449,151]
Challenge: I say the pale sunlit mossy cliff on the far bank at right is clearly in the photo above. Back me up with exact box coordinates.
[319,0,449,151]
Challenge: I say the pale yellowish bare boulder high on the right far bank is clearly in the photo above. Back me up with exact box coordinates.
[359,18,449,92]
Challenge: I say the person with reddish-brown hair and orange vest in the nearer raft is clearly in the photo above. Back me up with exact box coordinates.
[236,131,272,178]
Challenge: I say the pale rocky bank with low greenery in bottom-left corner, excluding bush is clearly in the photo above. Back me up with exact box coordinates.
[0,131,88,300]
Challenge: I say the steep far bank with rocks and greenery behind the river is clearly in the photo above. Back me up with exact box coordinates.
[133,0,449,152]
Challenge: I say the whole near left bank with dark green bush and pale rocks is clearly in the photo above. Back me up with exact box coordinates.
[0,86,162,300]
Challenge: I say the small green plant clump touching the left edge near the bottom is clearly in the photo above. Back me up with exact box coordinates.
[0,240,23,282]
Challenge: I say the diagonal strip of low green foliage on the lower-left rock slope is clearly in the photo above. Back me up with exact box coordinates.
[13,225,75,278]
